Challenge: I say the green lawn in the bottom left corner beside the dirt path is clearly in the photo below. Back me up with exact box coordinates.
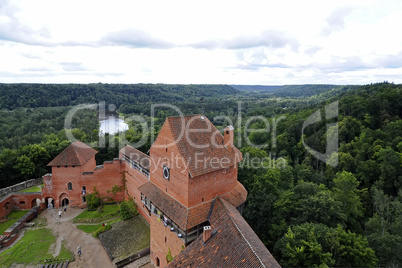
[0,228,73,267]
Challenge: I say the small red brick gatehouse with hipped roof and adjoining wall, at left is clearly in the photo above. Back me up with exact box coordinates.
[42,141,124,207]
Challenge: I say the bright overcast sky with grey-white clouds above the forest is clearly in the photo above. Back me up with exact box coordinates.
[0,0,402,85]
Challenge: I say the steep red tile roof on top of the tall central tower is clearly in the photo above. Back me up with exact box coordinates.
[166,115,242,178]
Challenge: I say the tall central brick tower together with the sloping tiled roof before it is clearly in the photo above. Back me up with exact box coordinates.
[139,115,279,267]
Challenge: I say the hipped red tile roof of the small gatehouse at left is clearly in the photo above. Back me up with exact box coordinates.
[48,141,98,166]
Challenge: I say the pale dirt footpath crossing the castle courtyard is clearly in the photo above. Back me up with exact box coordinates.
[39,208,115,268]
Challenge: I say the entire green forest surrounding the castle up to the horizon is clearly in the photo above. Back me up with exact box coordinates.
[0,82,402,267]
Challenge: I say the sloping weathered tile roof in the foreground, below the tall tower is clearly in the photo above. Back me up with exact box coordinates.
[168,197,280,267]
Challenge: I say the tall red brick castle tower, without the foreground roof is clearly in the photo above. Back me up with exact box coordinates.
[139,115,247,267]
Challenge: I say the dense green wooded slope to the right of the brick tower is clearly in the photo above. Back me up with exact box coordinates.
[239,83,402,267]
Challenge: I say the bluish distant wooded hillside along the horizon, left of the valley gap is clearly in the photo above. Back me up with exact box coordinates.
[0,84,240,110]
